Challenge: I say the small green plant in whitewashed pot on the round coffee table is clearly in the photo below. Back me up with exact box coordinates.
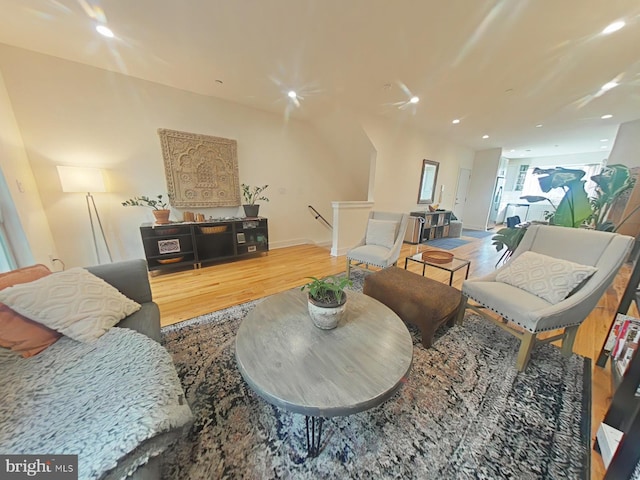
[301,276,353,330]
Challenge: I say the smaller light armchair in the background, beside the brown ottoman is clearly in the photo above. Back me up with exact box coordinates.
[347,211,409,278]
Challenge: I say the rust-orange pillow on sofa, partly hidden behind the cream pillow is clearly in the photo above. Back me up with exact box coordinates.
[0,264,62,358]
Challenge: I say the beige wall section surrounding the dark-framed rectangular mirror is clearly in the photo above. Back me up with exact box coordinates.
[363,117,474,213]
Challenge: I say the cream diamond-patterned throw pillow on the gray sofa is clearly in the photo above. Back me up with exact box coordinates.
[0,268,141,342]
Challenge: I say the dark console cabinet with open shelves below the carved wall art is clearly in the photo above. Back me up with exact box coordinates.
[140,217,269,271]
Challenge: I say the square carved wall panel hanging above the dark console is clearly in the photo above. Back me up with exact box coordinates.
[158,128,240,208]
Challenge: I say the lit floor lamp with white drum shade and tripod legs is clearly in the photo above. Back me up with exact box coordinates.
[57,166,113,263]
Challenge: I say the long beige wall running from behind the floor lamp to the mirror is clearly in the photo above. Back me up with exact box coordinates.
[0,44,490,267]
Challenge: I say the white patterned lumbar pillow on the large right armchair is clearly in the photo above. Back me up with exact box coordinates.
[496,252,598,304]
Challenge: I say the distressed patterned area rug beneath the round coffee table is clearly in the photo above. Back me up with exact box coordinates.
[162,272,591,480]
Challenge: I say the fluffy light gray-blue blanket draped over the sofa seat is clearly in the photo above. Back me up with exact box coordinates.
[0,328,192,479]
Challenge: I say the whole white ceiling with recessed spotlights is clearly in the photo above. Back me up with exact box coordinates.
[0,0,640,157]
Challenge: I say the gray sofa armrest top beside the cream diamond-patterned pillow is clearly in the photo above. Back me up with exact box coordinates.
[86,259,152,304]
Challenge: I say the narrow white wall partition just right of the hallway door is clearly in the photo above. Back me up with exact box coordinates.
[464,148,502,230]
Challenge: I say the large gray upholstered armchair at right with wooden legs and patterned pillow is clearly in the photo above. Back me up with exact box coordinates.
[458,225,633,371]
